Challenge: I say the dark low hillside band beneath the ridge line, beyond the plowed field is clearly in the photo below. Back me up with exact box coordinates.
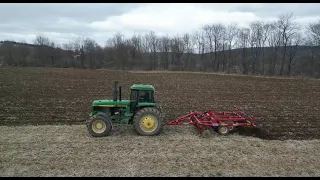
[0,41,320,78]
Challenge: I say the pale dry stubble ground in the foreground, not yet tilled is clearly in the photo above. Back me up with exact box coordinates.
[0,125,320,176]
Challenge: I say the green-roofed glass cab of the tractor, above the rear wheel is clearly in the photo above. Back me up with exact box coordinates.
[130,84,155,113]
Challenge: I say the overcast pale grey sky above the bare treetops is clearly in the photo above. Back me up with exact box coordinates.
[0,3,320,45]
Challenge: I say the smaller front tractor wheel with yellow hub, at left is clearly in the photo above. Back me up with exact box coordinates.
[87,115,112,137]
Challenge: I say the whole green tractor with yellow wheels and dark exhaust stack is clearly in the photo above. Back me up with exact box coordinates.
[87,81,163,137]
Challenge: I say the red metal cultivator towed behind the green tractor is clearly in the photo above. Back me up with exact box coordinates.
[165,106,256,137]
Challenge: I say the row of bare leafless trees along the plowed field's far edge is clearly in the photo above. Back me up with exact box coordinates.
[0,13,320,78]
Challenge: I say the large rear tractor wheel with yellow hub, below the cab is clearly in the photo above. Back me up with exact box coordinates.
[133,107,163,136]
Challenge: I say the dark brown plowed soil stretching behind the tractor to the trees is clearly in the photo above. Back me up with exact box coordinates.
[0,68,320,139]
